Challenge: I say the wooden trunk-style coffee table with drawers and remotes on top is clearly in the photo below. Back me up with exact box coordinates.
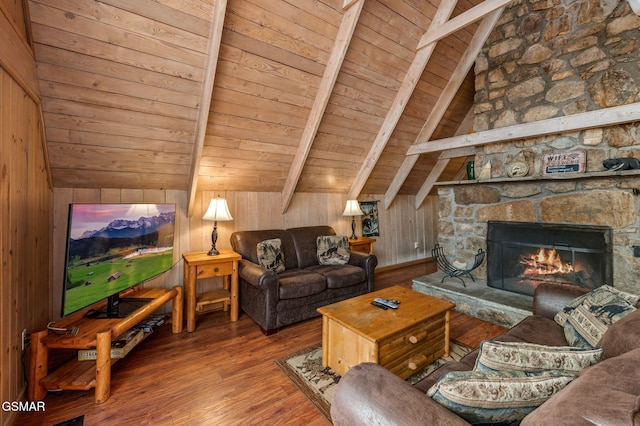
[318,286,455,379]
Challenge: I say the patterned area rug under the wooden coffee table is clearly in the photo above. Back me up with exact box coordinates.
[275,342,471,421]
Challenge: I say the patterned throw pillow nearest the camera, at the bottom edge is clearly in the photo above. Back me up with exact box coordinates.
[427,370,576,425]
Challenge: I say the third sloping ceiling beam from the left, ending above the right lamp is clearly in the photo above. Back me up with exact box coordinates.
[347,0,456,200]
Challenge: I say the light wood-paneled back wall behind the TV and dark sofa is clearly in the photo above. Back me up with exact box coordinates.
[53,188,437,318]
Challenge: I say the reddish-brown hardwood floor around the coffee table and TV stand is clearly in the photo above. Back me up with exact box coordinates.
[16,264,505,426]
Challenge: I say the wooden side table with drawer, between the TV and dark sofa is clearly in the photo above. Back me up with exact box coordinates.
[182,250,242,332]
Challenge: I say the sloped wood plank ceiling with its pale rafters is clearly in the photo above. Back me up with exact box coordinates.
[29,0,496,210]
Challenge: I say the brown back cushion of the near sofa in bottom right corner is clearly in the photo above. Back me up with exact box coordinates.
[522,349,640,426]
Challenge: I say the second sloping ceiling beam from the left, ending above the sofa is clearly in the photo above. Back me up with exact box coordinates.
[282,0,364,213]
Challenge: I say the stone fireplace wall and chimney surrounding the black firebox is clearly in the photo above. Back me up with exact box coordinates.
[437,0,640,293]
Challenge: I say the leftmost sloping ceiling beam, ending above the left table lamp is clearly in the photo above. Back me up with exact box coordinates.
[187,0,227,217]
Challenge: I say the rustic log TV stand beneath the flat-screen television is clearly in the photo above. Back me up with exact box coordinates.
[29,286,182,403]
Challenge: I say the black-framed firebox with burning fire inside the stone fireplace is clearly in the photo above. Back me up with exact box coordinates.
[487,221,613,295]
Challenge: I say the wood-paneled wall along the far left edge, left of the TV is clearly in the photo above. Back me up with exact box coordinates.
[0,0,53,425]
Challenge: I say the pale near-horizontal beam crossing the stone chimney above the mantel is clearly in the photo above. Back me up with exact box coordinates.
[408,102,640,155]
